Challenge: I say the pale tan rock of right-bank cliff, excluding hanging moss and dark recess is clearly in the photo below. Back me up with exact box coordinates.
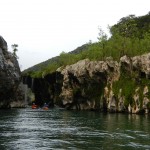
[60,53,150,113]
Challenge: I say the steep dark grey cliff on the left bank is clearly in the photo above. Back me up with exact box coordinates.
[0,36,24,108]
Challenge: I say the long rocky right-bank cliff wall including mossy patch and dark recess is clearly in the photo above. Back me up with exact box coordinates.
[24,53,150,113]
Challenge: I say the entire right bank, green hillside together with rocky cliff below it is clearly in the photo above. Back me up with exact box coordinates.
[23,14,150,113]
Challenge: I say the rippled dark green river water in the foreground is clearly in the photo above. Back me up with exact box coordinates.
[0,108,150,150]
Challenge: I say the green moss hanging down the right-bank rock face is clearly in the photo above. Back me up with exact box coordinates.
[113,72,150,108]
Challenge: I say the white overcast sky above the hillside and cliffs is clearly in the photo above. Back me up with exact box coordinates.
[0,0,150,70]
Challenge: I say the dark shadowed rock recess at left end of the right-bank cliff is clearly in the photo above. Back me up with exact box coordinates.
[23,72,63,107]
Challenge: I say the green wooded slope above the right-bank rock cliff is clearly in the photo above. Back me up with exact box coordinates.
[23,13,150,77]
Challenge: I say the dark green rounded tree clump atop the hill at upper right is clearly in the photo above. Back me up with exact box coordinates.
[110,13,150,39]
